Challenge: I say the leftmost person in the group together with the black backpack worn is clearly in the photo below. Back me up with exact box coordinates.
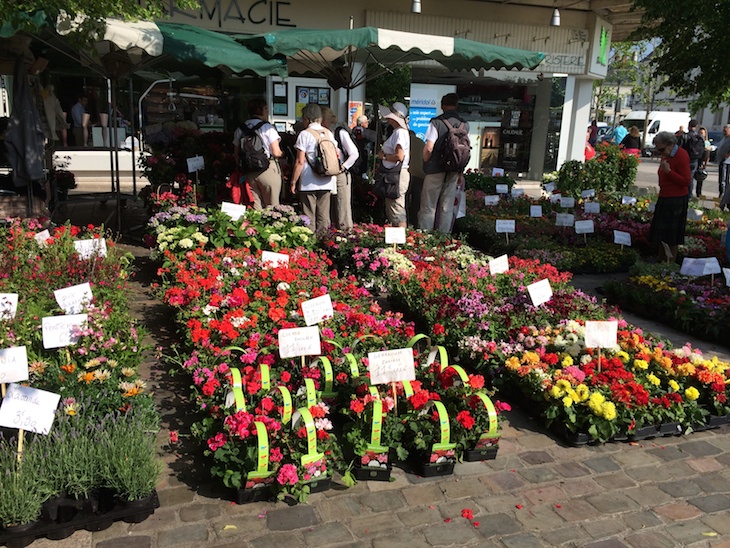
[233,97,282,209]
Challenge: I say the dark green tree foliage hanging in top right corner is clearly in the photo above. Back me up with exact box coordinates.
[633,0,730,110]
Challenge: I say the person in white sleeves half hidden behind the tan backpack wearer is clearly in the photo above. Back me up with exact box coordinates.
[322,107,360,230]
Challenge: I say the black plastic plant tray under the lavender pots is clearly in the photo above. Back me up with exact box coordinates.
[0,492,160,548]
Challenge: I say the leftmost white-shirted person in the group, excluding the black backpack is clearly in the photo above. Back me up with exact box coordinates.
[233,97,282,209]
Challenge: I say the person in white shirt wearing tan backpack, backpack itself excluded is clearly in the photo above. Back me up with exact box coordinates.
[291,103,337,234]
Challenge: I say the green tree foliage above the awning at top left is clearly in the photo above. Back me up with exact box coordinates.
[0,0,200,42]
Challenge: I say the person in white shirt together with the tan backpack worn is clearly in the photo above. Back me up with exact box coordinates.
[291,103,342,234]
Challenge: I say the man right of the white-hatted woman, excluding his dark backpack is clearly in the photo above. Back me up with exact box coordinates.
[418,93,469,234]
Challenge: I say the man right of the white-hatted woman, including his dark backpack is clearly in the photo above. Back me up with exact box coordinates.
[418,93,471,234]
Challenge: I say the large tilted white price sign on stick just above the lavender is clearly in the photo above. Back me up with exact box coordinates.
[0,384,61,434]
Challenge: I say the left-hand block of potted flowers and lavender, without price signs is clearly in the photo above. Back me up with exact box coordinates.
[0,221,161,544]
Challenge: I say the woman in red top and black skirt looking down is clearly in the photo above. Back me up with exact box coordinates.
[649,131,692,261]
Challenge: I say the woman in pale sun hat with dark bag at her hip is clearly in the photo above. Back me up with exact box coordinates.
[375,103,411,227]
